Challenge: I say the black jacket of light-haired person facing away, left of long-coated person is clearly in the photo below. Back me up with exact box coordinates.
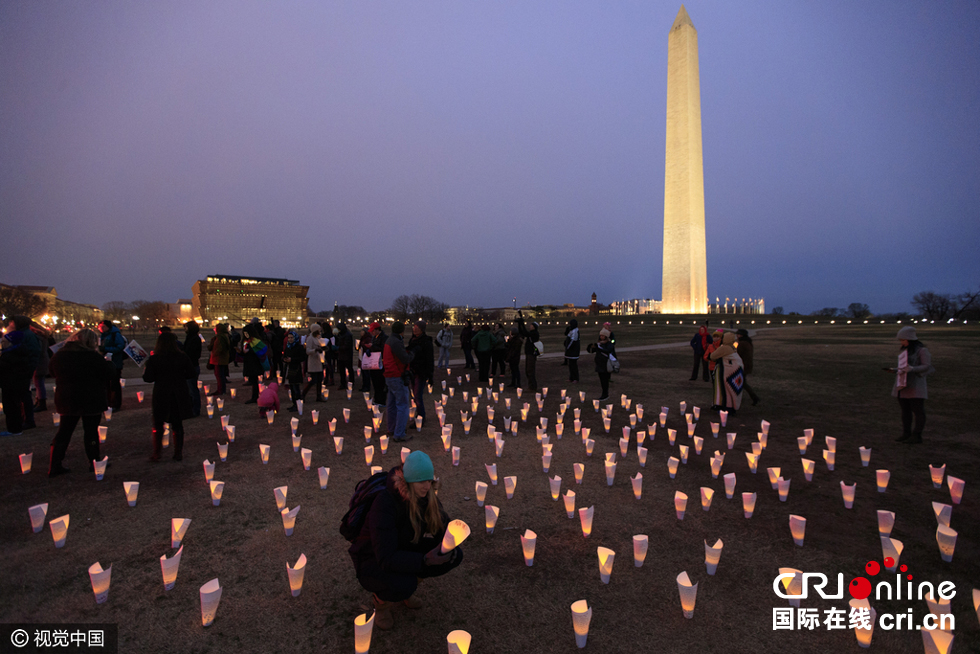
[48,342,116,416]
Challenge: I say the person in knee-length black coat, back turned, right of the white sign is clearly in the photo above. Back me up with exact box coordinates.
[143,332,194,461]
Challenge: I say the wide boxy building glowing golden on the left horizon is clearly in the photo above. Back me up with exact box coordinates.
[191,275,310,326]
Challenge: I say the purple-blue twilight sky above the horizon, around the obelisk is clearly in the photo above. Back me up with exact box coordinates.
[0,0,980,312]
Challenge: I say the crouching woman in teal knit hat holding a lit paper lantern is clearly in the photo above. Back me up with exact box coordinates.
[349,452,463,629]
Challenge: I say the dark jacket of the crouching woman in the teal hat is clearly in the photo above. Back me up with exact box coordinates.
[348,466,449,577]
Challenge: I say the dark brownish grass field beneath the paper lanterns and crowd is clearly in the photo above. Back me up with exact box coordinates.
[0,321,980,654]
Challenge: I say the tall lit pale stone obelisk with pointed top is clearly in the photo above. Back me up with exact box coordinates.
[661,5,708,313]
